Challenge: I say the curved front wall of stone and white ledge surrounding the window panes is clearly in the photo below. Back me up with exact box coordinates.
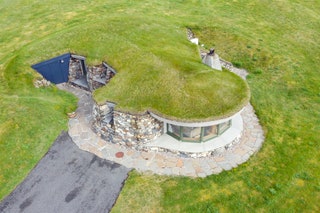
[92,100,243,157]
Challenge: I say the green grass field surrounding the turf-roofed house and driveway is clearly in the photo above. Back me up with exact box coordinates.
[0,0,320,212]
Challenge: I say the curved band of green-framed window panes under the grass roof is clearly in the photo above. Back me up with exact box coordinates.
[167,120,231,142]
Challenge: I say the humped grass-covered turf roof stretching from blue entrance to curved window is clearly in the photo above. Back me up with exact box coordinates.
[10,15,250,121]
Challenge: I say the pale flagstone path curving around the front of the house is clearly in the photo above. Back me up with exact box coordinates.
[59,81,264,177]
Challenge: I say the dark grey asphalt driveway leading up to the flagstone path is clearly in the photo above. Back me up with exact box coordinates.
[0,132,130,213]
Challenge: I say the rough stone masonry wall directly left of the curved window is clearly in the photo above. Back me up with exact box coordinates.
[92,104,163,150]
